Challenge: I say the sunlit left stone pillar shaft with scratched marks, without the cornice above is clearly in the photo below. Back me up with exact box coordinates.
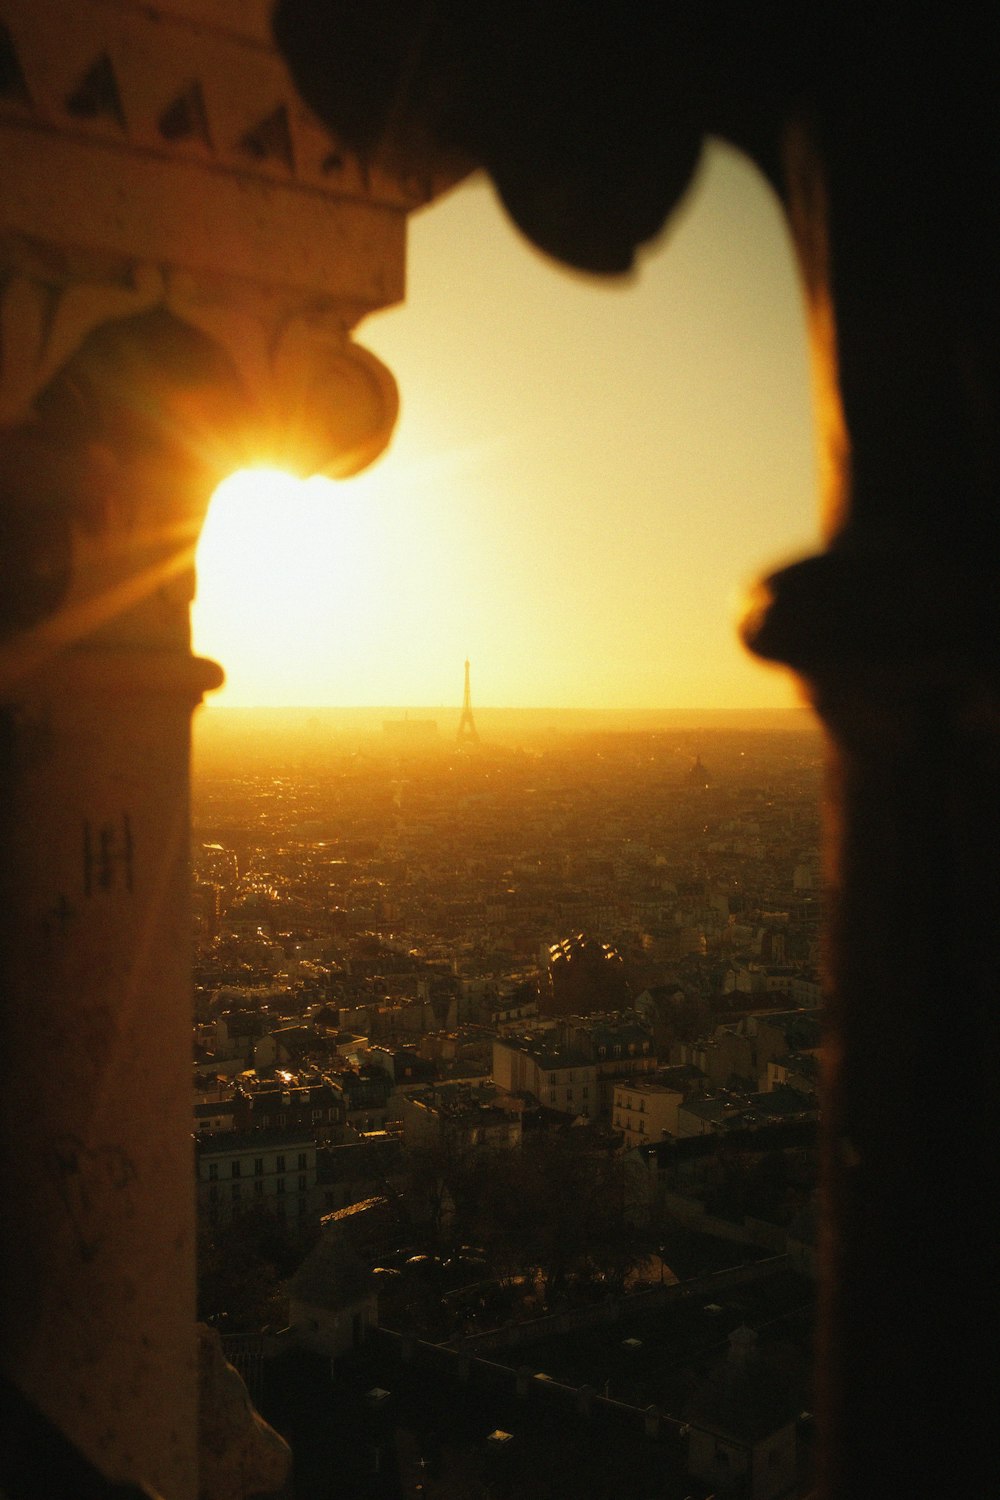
[0,314,240,1500]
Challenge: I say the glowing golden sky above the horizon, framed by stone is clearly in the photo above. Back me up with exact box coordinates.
[193,138,817,708]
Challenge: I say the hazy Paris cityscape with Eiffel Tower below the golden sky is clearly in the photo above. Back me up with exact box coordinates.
[192,684,822,1500]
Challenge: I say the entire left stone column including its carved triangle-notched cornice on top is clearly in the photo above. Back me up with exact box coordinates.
[0,0,446,1500]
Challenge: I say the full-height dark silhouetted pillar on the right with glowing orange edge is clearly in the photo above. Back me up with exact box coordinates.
[747,108,1000,1500]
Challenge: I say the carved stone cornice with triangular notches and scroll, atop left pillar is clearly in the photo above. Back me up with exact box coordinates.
[0,0,446,474]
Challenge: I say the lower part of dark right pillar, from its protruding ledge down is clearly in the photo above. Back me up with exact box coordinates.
[746,554,1000,1500]
